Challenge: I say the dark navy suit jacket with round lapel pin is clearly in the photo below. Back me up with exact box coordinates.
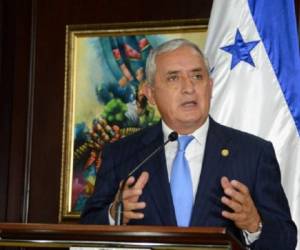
[81,118,297,250]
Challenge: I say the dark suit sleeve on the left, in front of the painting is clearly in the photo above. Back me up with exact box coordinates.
[80,146,119,225]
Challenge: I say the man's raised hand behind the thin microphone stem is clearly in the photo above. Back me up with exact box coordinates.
[110,172,149,224]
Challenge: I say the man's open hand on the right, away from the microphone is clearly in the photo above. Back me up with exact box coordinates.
[221,176,261,233]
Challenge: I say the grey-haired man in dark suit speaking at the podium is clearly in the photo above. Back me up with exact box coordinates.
[81,39,297,249]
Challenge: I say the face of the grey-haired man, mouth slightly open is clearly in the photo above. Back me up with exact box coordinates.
[147,46,212,134]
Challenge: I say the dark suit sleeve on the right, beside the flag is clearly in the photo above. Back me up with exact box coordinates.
[251,143,297,250]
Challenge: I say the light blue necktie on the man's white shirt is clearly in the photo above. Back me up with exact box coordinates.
[170,135,194,227]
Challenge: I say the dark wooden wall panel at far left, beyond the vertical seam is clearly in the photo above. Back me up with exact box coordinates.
[0,0,31,221]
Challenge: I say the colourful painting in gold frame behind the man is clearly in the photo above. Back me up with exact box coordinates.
[59,19,208,221]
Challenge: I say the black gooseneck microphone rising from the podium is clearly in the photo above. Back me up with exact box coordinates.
[115,131,178,226]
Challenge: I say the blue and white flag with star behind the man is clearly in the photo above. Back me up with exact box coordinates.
[205,0,300,246]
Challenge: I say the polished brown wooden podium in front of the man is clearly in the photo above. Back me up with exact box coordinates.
[0,223,244,250]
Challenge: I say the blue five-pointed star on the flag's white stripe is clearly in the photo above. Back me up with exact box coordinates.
[221,29,259,69]
